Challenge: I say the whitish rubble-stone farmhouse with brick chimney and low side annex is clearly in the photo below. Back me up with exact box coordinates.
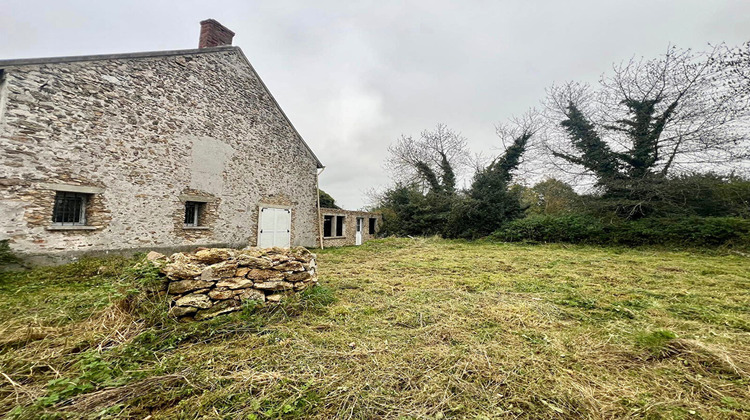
[0,19,380,262]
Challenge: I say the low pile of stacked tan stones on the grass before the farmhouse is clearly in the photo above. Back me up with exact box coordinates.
[161,247,318,320]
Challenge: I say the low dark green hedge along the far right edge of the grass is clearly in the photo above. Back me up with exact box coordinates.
[491,215,750,247]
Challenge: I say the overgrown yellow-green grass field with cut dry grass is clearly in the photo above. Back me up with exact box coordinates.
[0,239,750,419]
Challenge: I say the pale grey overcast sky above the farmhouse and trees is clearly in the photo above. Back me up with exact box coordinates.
[0,0,750,209]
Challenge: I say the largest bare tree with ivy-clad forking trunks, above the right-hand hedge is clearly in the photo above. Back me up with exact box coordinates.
[540,43,750,191]
